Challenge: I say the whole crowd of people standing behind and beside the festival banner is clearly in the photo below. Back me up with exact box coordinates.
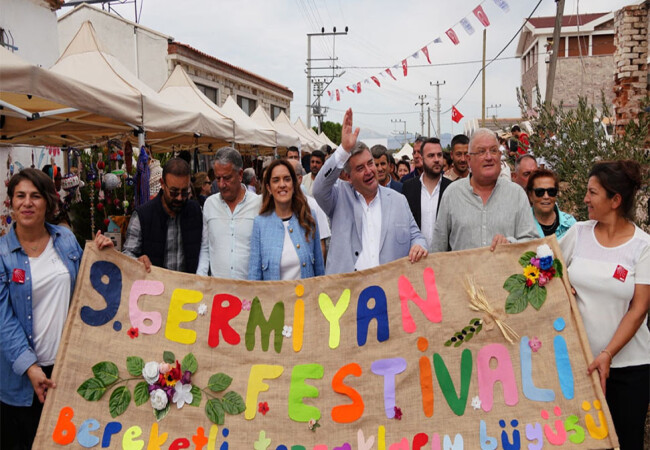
[0,110,650,449]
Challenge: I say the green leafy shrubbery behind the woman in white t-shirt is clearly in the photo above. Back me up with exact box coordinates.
[517,90,650,229]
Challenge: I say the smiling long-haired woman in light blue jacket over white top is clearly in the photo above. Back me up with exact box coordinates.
[248,159,325,280]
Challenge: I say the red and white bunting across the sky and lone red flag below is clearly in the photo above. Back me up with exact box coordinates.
[327,0,510,102]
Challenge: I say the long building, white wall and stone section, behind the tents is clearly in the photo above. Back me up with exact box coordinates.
[57,0,293,118]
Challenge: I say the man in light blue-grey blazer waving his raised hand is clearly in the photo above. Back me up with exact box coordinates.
[313,109,427,274]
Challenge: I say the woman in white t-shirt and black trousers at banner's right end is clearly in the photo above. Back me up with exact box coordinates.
[560,161,650,450]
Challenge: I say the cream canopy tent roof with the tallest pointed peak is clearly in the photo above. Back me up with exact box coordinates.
[51,21,234,146]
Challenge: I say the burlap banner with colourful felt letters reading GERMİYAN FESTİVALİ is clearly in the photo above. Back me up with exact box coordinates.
[34,238,617,450]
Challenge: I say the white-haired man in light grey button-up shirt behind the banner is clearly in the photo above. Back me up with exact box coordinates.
[432,128,540,252]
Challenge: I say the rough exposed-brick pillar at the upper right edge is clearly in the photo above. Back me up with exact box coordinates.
[614,1,650,137]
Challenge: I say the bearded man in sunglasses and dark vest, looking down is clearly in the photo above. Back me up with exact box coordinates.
[122,158,203,273]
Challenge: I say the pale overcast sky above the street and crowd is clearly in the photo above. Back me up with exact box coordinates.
[86,0,638,139]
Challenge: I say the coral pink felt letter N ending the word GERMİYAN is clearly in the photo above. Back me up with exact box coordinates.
[397,267,442,333]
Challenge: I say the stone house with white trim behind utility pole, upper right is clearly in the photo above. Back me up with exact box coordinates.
[516,12,616,108]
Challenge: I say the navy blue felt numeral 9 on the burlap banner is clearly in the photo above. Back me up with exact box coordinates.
[79,261,122,327]
